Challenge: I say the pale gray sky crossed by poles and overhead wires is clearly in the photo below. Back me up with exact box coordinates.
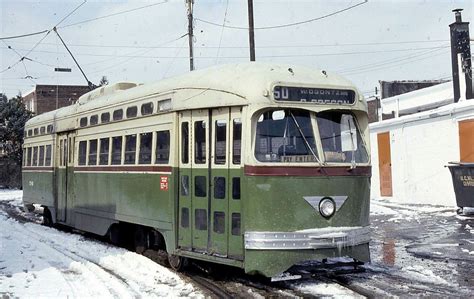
[0,0,474,97]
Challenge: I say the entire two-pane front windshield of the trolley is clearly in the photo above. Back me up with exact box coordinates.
[255,109,369,164]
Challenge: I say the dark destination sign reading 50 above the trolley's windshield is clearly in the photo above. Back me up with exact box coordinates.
[273,85,355,105]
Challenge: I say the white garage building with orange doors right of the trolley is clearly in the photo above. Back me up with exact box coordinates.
[370,82,474,206]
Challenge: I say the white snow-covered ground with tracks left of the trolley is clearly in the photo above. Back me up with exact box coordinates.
[0,190,203,298]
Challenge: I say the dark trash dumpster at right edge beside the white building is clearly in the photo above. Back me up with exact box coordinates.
[448,162,474,208]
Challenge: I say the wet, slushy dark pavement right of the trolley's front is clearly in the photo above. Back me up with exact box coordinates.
[348,200,474,297]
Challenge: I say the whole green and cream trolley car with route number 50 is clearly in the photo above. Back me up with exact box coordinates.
[23,63,370,277]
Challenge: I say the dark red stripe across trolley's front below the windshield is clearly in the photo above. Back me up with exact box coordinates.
[244,165,372,177]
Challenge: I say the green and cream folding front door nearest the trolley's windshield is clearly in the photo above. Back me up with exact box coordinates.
[178,108,243,258]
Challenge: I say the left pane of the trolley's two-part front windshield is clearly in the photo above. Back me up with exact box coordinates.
[255,109,319,162]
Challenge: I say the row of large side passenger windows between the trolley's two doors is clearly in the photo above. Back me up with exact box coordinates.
[78,130,170,166]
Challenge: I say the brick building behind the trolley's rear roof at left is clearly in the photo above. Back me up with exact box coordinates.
[23,84,90,115]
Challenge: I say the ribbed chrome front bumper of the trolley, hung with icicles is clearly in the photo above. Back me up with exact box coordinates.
[245,226,370,250]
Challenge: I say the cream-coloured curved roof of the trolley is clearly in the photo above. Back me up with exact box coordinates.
[27,62,355,127]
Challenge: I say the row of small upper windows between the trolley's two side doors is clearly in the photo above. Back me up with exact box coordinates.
[79,99,171,128]
